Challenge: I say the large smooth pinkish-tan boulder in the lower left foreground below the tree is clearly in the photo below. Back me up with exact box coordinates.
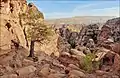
[16,66,36,76]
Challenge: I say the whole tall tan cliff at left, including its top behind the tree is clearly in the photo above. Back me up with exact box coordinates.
[0,0,44,55]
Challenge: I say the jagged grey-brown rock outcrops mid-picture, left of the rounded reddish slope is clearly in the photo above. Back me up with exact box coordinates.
[58,24,100,53]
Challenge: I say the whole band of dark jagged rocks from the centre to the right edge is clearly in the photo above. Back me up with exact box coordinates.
[57,18,120,53]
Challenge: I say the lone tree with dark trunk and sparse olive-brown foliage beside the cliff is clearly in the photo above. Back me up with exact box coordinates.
[24,9,52,57]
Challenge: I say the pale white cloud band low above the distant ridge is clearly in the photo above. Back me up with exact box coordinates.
[45,4,120,19]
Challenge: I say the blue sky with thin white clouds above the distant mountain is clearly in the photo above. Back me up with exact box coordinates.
[27,0,120,19]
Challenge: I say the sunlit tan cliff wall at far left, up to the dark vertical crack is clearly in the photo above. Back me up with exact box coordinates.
[0,0,27,55]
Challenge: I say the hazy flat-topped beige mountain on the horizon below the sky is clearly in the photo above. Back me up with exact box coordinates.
[45,16,115,24]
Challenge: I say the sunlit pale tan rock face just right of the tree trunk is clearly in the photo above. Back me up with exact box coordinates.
[35,33,59,56]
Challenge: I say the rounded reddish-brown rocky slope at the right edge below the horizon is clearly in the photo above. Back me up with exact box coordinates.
[98,17,120,54]
